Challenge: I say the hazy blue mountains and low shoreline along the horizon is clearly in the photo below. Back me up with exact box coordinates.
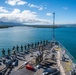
[0,21,76,28]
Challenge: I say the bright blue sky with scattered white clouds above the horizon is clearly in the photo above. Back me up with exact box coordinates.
[0,0,76,25]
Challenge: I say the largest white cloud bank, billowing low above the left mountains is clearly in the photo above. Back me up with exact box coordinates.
[0,9,50,24]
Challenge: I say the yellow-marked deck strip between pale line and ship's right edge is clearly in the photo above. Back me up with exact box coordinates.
[54,44,76,75]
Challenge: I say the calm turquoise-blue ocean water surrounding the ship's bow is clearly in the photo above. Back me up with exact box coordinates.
[0,27,76,58]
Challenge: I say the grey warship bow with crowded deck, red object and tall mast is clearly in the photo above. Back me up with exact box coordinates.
[0,13,76,75]
